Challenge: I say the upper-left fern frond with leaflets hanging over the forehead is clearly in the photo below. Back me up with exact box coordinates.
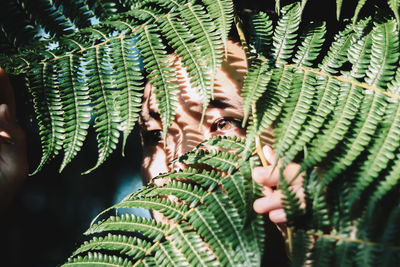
[0,0,233,173]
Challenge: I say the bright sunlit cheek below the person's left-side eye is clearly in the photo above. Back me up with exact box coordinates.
[142,147,168,183]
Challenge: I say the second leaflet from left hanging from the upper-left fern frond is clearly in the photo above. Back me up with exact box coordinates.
[57,54,92,172]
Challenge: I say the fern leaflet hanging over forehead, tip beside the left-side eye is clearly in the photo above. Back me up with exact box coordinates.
[138,25,177,138]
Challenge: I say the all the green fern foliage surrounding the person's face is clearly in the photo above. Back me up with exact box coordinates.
[0,0,400,266]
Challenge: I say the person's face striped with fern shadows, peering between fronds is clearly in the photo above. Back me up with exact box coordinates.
[140,42,247,184]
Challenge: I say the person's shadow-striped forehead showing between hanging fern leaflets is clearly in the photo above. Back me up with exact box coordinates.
[141,42,247,121]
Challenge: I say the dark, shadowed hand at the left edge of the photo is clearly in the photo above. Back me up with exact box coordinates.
[0,68,28,211]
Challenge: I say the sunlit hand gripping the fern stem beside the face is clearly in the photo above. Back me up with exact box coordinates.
[252,145,304,223]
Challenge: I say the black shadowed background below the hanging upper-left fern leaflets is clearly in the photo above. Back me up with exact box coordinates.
[0,76,142,266]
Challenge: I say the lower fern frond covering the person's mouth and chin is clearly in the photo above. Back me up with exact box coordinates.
[65,138,264,266]
